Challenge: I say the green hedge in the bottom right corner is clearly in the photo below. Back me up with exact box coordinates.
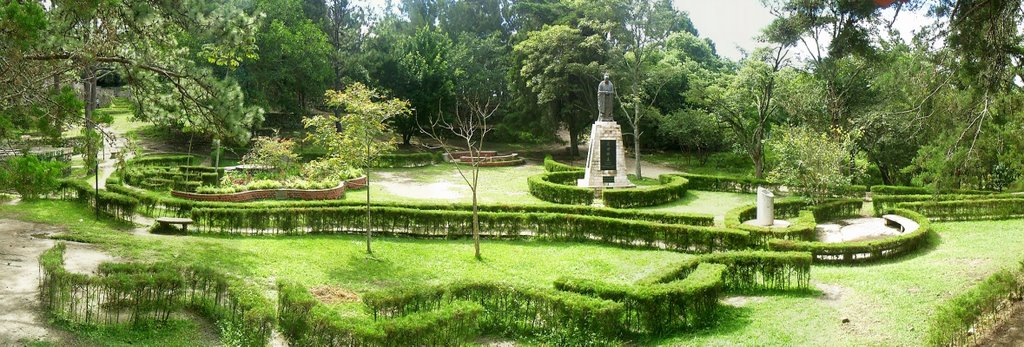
[926,263,1024,346]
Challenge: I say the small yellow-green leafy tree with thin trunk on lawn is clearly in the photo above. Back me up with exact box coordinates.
[302,83,410,254]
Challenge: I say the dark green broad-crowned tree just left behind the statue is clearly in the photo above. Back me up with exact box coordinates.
[514,25,605,157]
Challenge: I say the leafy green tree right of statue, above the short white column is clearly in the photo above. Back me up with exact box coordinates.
[693,46,786,178]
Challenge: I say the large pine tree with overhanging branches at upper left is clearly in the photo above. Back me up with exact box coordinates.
[0,1,262,157]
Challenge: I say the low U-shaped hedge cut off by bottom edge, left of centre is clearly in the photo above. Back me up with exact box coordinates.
[278,281,484,346]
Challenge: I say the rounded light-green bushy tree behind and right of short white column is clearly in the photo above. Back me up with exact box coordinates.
[768,127,865,202]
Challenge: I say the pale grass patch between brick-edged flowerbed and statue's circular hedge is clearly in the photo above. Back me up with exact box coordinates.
[345,164,550,205]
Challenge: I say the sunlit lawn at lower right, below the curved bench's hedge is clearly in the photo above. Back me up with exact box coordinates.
[659,220,1024,346]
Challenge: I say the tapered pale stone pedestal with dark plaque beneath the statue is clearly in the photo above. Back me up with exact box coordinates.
[577,120,636,188]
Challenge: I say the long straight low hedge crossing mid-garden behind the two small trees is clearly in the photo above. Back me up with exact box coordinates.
[189,207,749,253]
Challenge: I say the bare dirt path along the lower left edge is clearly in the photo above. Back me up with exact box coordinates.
[0,219,58,346]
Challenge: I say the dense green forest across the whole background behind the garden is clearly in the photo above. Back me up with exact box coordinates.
[0,0,1024,189]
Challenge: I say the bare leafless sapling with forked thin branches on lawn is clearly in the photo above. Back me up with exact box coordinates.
[420,95,500,259]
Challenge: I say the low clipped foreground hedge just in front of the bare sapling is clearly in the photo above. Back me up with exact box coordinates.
[362,280,624,346]
